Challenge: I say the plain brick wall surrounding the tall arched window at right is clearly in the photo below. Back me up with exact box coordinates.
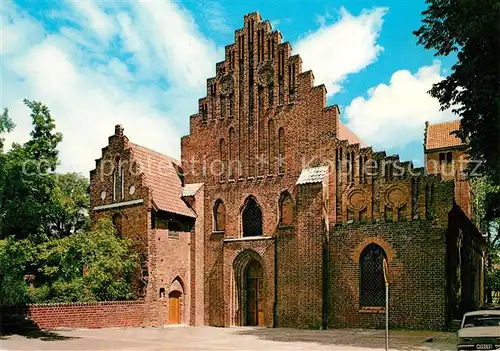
[329,221,446,329]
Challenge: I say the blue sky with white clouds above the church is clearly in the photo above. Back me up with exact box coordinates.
[0,0,457,176]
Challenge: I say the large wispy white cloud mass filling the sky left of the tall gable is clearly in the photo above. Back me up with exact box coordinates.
[1,1,221,175]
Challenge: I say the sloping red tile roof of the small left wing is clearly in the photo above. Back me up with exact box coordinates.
[128,142,195,217]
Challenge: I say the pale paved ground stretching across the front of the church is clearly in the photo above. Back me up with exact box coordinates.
[0,326,455,351]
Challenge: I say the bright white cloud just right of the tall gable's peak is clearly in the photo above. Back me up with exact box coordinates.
[294,7,387,95]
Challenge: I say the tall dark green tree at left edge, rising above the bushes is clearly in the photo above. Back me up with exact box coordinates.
[0,100,62,241]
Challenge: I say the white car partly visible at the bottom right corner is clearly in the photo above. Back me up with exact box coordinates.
[457,310,500,351]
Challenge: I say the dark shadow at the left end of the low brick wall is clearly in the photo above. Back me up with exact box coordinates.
[0,311,75,341]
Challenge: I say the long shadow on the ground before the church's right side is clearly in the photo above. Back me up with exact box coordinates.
[236,328,456,351]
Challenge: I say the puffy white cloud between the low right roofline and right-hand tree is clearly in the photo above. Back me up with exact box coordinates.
[345,61,457,148]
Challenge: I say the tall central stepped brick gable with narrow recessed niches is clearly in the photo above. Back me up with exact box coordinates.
[181,12,371,184]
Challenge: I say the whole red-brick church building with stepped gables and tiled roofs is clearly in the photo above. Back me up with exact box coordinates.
[91,13,486,329]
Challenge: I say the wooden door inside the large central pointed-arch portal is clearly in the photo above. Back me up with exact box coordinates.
[245,260,264,327]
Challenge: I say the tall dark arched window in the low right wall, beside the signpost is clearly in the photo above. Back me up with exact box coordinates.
[359,244,387,307]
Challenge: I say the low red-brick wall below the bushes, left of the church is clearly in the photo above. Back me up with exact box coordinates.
[28,301,151,329]
